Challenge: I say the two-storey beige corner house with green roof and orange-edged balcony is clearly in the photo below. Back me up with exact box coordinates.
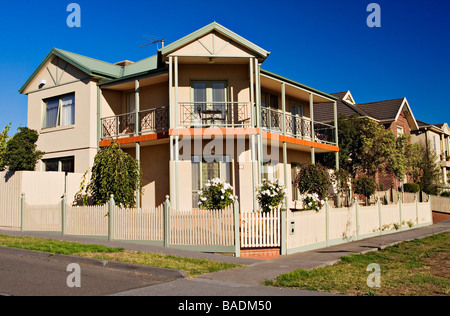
[20,22,339,211]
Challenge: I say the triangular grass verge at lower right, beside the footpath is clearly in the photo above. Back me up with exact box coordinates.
[265,232,450,296]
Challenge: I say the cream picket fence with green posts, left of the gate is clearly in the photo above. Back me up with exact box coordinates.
[21,198,237,250]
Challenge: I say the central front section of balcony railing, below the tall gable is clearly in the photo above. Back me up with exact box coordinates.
[179,102,252,128]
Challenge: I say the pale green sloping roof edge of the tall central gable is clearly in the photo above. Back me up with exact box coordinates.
[159,22,270,59]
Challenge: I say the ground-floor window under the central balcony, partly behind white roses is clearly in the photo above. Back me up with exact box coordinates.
[192,156,231,208]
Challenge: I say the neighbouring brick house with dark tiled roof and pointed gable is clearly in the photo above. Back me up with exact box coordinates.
[314,91,419,190]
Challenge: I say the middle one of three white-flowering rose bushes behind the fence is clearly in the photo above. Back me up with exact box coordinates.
[257,179,287,212]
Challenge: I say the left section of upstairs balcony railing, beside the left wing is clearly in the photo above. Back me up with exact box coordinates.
[101,107,169,139]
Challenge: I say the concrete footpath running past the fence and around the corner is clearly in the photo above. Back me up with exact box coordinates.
[0,220,450,296]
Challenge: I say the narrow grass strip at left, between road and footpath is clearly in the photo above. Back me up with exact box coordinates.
[0,235,242,277]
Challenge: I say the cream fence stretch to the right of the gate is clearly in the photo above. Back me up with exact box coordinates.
[287,201,433,253]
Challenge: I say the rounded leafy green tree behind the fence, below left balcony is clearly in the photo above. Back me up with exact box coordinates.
[86,142,142,208]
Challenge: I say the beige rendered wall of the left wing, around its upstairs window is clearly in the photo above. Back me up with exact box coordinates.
[25,61,97,173]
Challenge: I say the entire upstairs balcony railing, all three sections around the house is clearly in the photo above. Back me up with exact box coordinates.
[101,102,336,146]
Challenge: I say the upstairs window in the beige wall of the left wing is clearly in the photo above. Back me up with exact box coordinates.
[43,94,75,128]
